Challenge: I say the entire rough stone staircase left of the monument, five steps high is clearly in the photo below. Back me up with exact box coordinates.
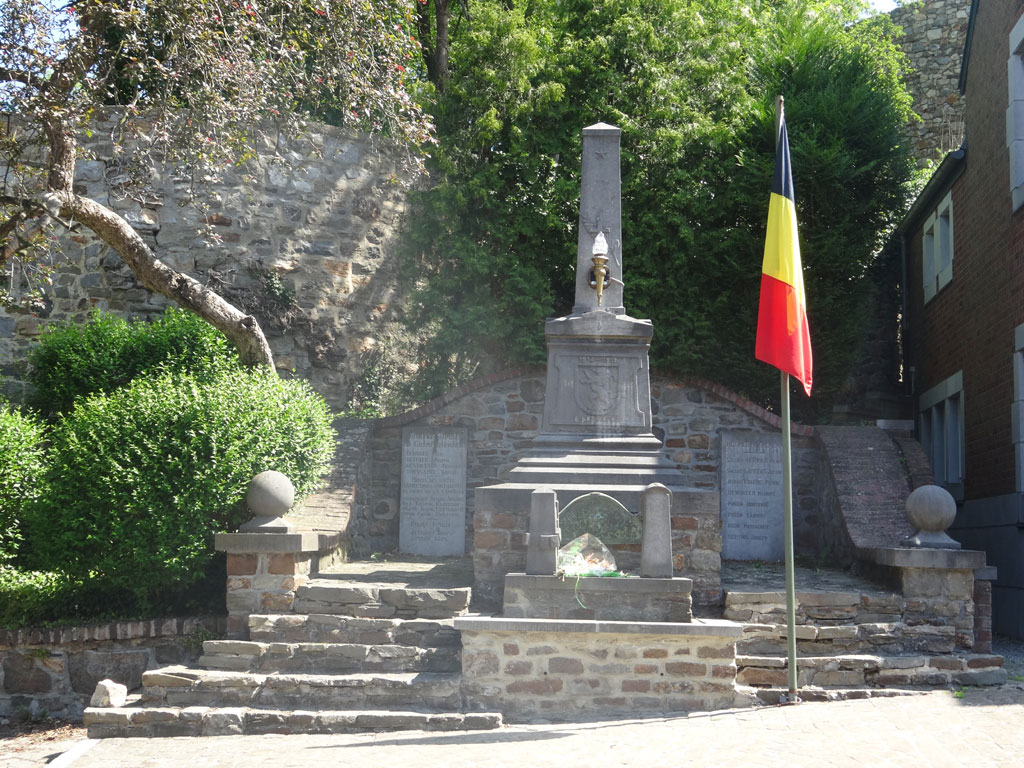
[85,563,502,738]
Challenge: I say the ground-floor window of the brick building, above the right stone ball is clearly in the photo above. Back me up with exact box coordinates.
[918,371,964,500]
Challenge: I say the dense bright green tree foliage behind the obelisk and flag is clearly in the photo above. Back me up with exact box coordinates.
[397,0,912,417]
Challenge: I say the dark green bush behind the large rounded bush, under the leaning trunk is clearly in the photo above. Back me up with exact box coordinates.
[28,307,238,415]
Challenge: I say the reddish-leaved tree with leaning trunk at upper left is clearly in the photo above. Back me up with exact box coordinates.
[0,0,430,365]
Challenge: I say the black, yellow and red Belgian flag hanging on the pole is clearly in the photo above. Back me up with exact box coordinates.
[755,115,812,396]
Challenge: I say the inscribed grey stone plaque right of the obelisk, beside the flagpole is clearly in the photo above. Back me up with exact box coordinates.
[722,432,784,562]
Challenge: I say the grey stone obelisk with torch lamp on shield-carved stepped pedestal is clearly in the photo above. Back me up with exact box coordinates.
[473,123,709,605]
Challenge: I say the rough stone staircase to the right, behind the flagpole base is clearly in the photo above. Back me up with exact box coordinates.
[723,564,1007,703]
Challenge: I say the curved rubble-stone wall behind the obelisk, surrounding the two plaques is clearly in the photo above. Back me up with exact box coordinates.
[348,370,820,604]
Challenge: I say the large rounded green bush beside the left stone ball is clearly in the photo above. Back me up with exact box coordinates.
[26,369,334,612]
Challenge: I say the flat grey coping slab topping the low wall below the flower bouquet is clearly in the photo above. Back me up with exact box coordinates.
[455,616,743,637]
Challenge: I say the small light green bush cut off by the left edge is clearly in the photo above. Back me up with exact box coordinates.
[0,400,43,563]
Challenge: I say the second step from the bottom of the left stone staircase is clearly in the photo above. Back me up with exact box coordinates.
[141,667,462,711]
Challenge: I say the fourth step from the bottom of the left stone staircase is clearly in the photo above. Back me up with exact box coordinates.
[249,613,462,648]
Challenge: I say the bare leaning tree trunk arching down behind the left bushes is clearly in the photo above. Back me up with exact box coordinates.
[46,120,273,371]
